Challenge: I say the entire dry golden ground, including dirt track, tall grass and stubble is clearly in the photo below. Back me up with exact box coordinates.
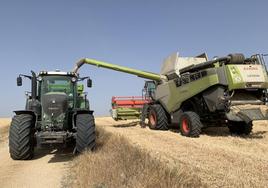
[0,117,268,187]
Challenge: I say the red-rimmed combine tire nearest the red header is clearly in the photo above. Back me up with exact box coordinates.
[148,104,168,130]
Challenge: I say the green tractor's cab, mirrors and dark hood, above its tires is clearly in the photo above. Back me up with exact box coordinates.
[17,70,92,130]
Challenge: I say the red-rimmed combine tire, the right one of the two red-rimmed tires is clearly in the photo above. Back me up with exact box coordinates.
[180,111,203,137]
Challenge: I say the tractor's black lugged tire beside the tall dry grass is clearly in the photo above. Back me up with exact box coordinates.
[76,114,96,153]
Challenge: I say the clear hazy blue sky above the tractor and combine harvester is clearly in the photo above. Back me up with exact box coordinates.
[0,0,268,117]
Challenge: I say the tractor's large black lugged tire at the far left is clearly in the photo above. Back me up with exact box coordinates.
[9,114,34,160]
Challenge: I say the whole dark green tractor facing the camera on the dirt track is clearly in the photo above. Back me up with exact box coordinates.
[9,70,96,160]
